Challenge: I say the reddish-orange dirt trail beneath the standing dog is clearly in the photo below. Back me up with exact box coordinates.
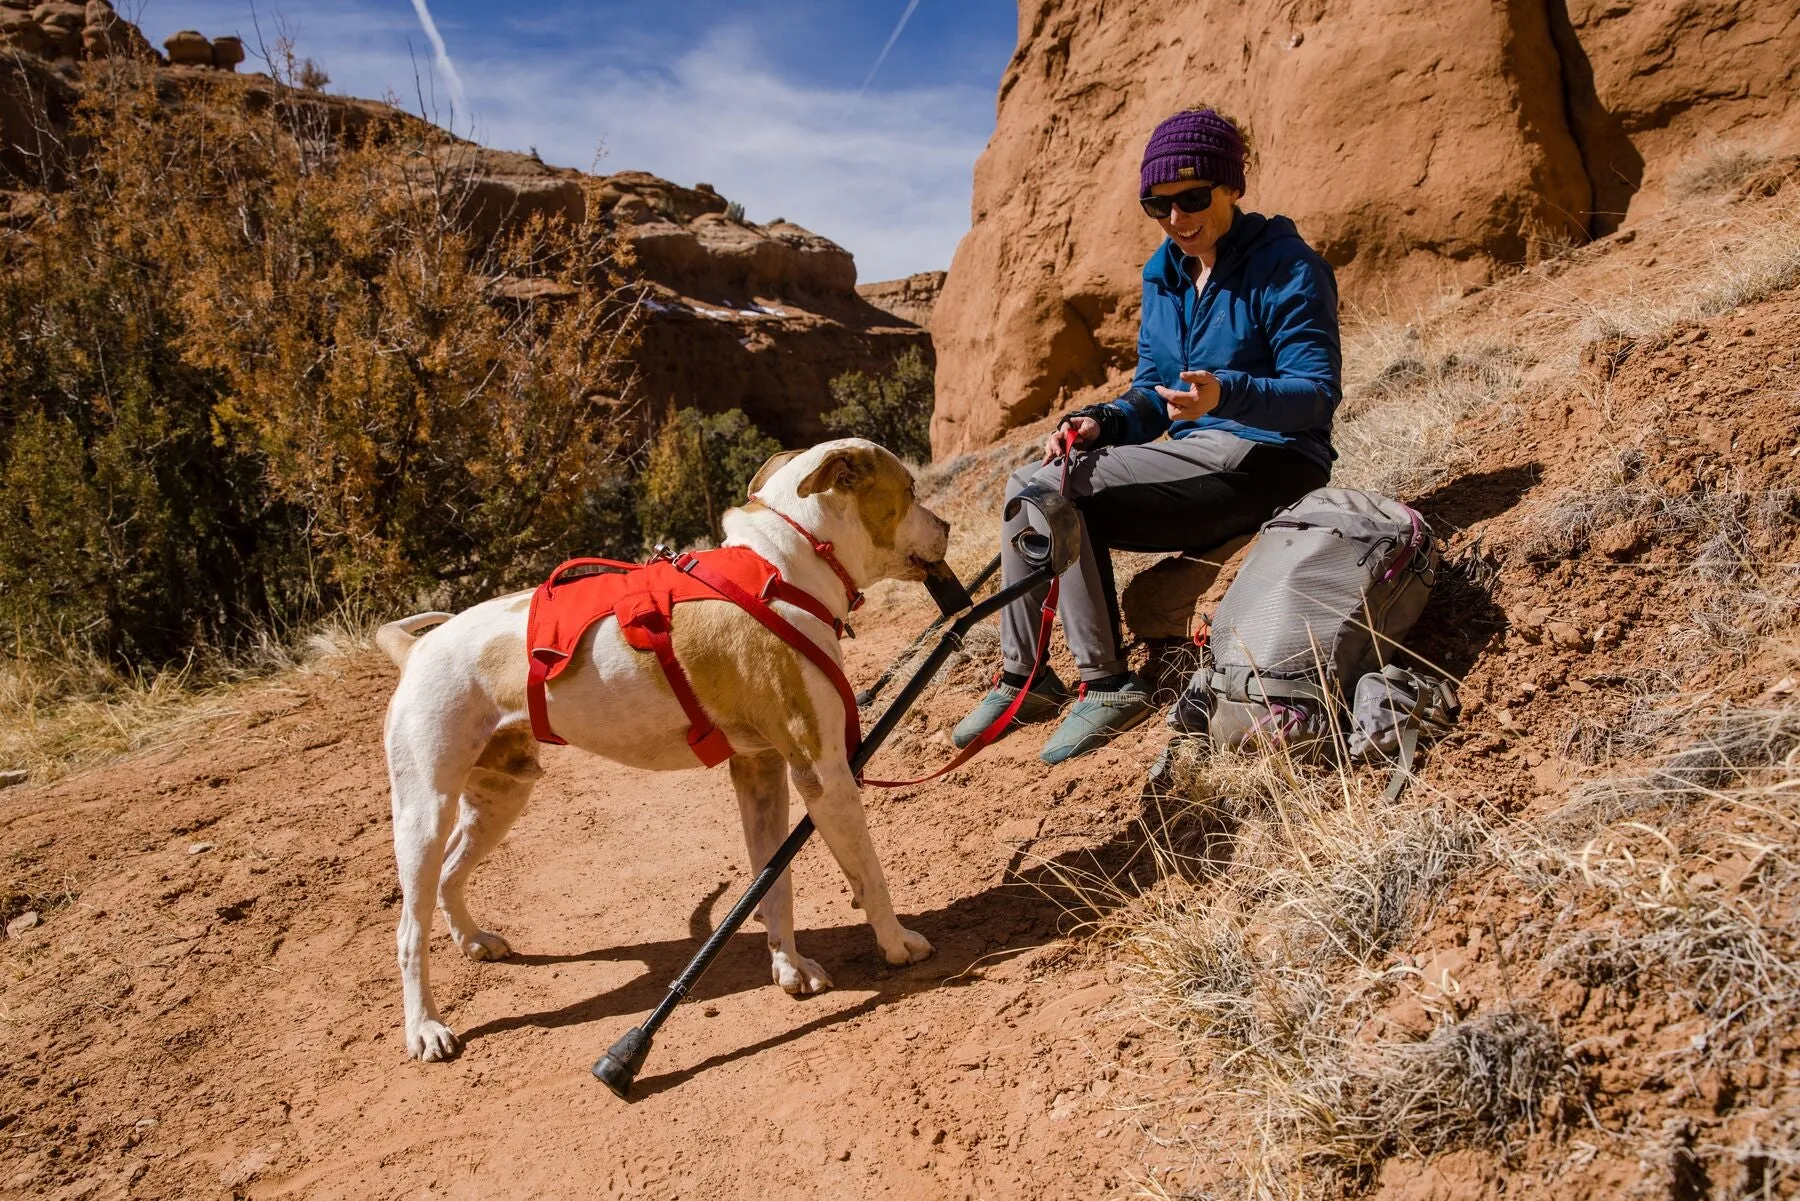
[0,601,1180,1197]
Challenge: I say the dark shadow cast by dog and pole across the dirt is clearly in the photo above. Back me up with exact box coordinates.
[463,807,1166,1097]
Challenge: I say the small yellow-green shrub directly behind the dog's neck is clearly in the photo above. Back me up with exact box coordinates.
[637,409,781,547]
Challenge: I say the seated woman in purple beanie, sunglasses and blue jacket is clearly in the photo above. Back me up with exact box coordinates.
[954,108,1341,763]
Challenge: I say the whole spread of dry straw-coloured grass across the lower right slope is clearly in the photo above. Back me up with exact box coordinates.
[1116,709,1800,1197]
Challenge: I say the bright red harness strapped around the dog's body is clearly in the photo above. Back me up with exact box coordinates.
[526,547,862,767]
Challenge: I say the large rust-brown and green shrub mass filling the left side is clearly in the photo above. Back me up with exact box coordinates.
[0,68,635,664]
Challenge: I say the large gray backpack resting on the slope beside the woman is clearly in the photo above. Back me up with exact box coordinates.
[1168,488,1442,770]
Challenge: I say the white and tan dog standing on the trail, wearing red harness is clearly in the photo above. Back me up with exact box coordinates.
[376,438,949,1061]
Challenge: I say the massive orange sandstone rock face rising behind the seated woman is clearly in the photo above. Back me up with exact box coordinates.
[932,0,1800,454]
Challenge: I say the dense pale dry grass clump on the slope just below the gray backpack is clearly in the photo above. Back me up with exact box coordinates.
[1111,744,1540,1197]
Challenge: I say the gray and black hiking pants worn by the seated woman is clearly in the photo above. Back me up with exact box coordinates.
[1001,430,1330,681]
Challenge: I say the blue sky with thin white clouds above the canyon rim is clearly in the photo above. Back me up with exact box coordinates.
[130,0,1017,281]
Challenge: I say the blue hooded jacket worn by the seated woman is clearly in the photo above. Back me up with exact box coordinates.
[1105,212,1343,472]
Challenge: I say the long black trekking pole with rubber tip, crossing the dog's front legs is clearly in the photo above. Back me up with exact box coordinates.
[592,486,1080,1100]
